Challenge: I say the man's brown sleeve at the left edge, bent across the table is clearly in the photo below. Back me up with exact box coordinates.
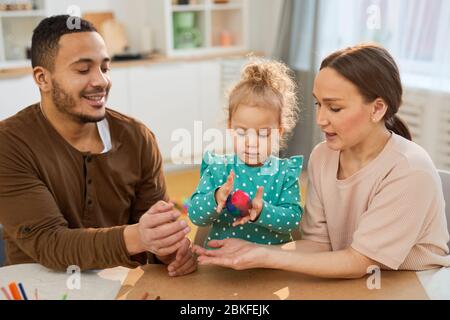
[0,132,145,271]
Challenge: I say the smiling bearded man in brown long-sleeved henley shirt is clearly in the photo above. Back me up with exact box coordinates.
[0,16,196,276]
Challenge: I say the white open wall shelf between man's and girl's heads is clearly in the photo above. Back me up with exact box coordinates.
[149,0,248,57]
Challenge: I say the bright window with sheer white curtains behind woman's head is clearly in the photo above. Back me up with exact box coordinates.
[318,0,450,90]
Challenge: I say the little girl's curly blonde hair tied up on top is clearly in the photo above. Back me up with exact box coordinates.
[228,58,299,148]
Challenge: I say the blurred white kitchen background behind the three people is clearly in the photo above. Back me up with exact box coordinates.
[0,0,450,171]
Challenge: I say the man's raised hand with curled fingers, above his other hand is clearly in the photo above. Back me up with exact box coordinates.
[124,201,190,257]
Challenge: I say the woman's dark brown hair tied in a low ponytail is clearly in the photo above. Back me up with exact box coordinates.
[320,44,412,140]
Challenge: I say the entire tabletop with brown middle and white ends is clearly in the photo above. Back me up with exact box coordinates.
[0,264,450,300]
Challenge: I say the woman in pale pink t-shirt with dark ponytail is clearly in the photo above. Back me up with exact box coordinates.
[194,45,450,278]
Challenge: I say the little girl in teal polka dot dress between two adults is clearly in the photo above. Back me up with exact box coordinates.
[189,60,303,245]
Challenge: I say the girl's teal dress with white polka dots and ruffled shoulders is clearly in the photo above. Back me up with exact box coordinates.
[189,152,303,245]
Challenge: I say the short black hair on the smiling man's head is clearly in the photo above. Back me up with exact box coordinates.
[31,15,97,71]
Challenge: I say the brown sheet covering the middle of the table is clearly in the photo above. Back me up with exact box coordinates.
[117,265,428,300]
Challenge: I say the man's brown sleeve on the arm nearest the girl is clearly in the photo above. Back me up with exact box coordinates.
[130,125,169,224]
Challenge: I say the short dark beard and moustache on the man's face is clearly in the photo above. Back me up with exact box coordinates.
[52,79,109,124]
